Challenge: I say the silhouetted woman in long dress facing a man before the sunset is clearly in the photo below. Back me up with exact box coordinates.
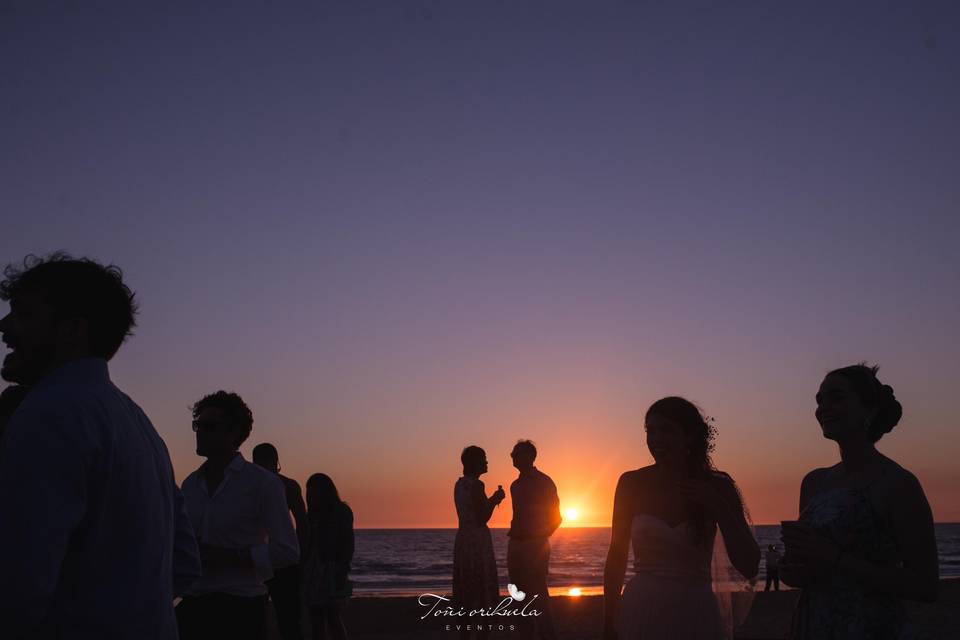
[453,445,506,638]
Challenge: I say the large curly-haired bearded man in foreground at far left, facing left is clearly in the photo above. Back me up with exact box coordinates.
[0,253,200,640]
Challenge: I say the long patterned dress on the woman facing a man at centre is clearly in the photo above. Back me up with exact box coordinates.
[453,476,500,610]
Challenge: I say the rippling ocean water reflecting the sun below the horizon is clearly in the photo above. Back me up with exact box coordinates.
[350,524,960,596]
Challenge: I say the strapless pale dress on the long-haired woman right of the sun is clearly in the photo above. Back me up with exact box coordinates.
[617,514,728,640]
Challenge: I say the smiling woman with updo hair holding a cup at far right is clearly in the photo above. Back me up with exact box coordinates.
[780,363,939,640]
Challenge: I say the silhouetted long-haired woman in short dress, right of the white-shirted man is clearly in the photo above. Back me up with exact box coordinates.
[303,473,353,640]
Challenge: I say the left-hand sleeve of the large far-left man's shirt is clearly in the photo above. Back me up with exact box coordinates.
[0,409,90,638]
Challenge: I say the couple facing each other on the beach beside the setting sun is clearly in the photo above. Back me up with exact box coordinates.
[453,440,562,640]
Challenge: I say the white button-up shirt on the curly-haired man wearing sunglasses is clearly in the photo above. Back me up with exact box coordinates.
[181,453,300,596]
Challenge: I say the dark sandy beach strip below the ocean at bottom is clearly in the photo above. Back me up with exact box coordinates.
[271,580,960,640]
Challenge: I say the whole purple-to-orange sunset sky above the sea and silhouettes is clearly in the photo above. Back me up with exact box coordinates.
[0,1,960,527]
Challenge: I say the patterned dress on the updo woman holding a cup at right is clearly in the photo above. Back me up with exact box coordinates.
[791,487,910,640]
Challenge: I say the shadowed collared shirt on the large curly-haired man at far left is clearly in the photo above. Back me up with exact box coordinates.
[0,358,200,640]
